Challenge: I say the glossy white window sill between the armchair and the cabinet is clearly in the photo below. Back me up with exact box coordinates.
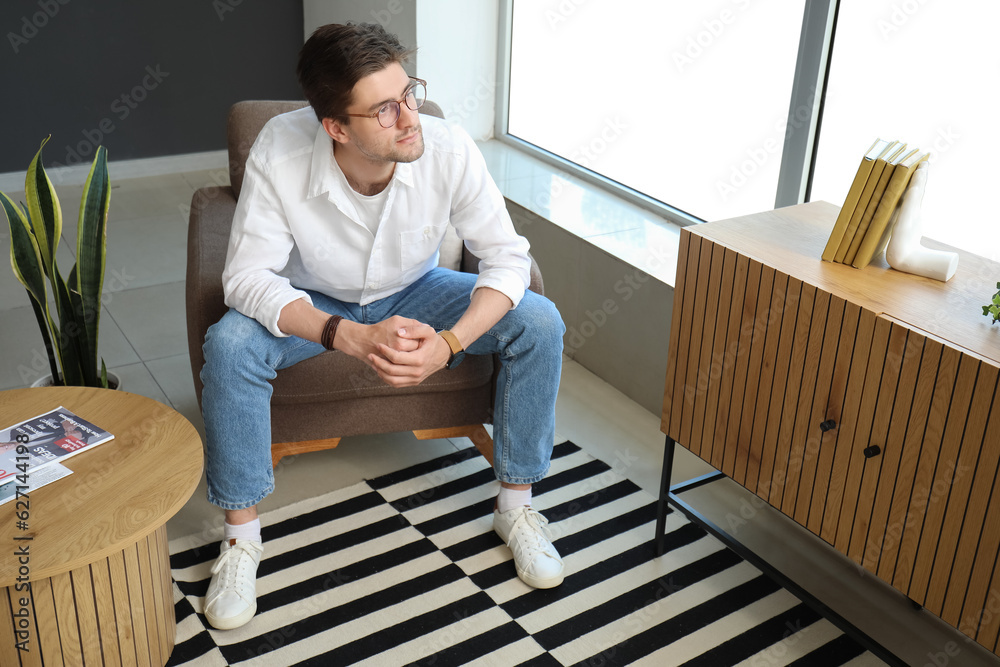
[478,139,681,287]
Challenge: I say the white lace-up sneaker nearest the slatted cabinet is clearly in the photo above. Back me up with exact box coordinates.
[493,506,563,588]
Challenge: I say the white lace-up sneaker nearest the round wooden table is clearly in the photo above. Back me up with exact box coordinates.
[205,540,264,630]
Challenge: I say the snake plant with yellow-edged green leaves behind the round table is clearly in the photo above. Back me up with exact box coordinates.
[0,136,111,388]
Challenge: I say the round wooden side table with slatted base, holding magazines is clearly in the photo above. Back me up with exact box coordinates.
[0,387,203,667]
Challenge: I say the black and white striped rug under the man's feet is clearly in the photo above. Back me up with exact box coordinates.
[169,442,884,667]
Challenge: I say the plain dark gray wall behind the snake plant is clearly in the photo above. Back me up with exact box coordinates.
[0,0,302,172]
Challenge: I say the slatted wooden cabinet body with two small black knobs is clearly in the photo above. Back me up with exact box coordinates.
[662,202,1000,653]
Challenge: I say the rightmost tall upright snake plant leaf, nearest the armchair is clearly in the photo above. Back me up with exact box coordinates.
[71,146,111,378]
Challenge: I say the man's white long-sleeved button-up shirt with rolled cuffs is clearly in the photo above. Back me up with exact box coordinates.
[222,107,531,336]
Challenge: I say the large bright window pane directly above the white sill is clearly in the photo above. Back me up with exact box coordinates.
[507,0,804,220]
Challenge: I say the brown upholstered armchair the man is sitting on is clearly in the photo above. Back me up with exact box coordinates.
[186,101,542,466]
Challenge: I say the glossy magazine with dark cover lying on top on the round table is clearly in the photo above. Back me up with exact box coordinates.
[0,406,115,484]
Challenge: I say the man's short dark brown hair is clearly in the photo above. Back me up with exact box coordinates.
[296,23,413,124]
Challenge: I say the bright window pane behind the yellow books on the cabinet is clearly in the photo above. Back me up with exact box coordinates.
[810,0,1000,258]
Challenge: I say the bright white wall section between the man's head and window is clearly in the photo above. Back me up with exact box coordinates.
[416,0,499,141]
